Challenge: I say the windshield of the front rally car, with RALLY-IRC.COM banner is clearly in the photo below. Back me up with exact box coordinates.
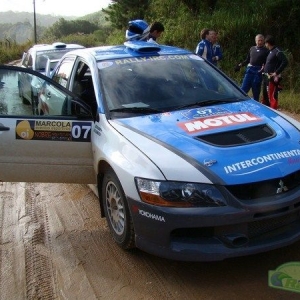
[98,55,248,113]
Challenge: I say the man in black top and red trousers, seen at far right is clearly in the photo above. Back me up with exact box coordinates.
[262,35,288,109]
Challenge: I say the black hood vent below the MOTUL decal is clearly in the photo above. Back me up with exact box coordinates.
[195,124,276,147]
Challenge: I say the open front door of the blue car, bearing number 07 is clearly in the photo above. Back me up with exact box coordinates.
[0,66,96,183]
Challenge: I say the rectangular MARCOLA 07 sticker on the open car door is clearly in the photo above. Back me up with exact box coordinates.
[16,120,91,142]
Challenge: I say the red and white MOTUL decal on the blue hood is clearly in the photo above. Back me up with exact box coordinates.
[178,112,261,133]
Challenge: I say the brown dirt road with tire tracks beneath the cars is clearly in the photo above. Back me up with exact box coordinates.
[0,183,300,300]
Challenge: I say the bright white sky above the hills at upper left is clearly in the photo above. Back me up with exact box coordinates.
[0,0,110,17]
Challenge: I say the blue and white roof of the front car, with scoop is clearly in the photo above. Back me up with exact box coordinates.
[61,41,192,61]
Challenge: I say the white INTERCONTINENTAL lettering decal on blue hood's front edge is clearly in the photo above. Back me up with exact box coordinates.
[224,149,300,174]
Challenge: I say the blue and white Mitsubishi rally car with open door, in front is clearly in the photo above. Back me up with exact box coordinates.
[0,42,300,261]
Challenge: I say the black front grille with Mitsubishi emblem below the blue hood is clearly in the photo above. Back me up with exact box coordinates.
[226,171,300,200]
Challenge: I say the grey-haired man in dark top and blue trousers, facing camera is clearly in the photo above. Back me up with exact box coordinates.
[236,34,269,101]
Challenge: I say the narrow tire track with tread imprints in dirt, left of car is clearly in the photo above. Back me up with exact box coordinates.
[24,183,56,300]
